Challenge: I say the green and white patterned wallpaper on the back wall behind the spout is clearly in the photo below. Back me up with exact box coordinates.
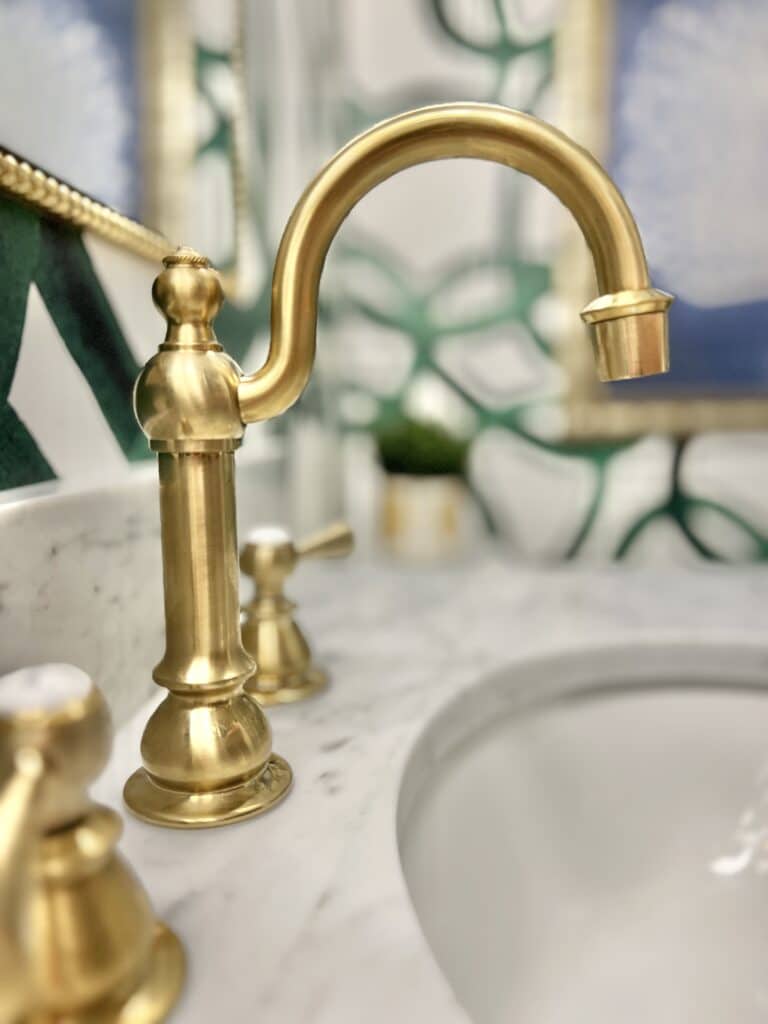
[323,0,768,563]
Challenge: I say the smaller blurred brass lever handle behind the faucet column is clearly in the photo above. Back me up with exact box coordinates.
[240,522,353,705]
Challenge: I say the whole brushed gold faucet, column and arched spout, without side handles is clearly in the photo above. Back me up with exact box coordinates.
[125,103,672,827]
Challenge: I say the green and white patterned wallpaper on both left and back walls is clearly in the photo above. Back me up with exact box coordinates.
[0,0,768,563]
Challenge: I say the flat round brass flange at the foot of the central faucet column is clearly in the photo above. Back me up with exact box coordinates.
[123,754,293,828]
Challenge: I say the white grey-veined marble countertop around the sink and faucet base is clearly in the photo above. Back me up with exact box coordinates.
[94,561,768,1024]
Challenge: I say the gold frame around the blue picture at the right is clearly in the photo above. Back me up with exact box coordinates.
[555,0,768,441]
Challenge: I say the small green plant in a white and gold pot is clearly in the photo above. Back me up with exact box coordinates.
[376,419,469,561]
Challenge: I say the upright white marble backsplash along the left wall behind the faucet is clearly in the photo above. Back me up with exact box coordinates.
[0,451,285,721]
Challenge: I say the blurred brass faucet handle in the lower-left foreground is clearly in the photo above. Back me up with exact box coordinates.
[0,671,184,1024]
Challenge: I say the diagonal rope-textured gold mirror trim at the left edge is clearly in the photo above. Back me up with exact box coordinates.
[0,148,176,262]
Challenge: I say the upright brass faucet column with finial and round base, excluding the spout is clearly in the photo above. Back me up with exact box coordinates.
[125,249,292,828]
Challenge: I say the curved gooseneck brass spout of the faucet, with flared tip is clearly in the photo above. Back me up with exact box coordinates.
[238,103,672,423]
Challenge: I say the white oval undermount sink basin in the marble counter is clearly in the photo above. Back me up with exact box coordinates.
[398,643,768,1024]
